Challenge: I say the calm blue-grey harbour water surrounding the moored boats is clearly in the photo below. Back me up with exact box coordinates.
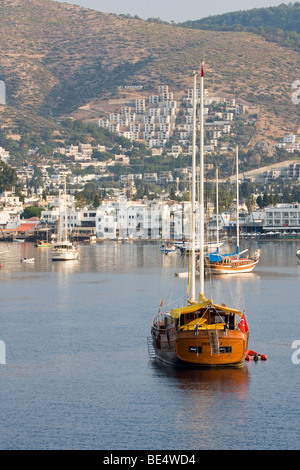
[0,242,300,450]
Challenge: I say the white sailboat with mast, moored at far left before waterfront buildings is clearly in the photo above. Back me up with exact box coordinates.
[51,180,78,261]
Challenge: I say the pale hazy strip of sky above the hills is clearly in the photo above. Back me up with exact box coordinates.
[56,0,293,23]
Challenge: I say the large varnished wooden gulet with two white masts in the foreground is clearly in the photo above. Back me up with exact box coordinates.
[151,63,249,367]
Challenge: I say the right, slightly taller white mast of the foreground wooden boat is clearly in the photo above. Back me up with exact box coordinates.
[199,62,204,297]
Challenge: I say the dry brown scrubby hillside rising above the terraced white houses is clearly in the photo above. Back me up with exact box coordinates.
[0,0,300,144]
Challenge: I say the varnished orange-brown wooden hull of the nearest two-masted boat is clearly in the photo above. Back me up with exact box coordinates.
[152,328,248,368]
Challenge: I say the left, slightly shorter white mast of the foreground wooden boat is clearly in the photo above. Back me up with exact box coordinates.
[190,72,197,302]
